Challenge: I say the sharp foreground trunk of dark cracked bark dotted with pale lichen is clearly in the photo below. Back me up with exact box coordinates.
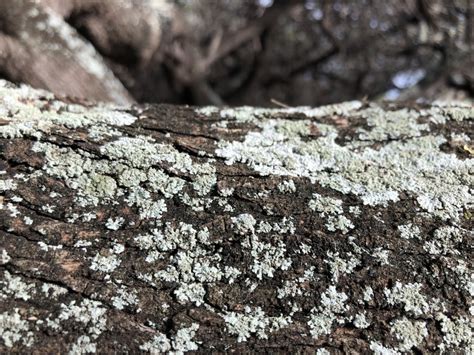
[0,82,474,354]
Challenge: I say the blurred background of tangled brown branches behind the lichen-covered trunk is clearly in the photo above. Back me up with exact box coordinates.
[0,0,474,106]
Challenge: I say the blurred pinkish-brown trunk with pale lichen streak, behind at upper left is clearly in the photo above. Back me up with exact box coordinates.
[0,0,172,104]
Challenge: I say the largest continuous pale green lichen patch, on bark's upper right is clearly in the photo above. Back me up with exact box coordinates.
[216,107,474,222]
